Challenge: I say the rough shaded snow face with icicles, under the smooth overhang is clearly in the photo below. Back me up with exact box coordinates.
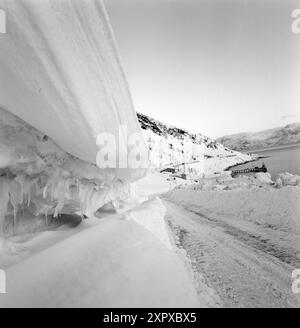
[0,109,144,235]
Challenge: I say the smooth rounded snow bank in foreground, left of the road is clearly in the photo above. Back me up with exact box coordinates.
[0,205,205,307]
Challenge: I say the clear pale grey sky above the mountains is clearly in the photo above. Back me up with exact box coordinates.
[104,0,300,138]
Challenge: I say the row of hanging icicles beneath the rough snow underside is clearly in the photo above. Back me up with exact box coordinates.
[0,175,130,234]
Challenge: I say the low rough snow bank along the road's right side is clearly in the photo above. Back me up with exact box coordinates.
[168,184,300,231]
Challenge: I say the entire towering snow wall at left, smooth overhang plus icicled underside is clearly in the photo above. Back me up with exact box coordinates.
[0,0,147,233]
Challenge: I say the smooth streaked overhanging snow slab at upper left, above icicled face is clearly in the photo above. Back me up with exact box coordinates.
[0,0,146,172]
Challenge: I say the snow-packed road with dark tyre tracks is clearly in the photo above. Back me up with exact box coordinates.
[164,199,300,307]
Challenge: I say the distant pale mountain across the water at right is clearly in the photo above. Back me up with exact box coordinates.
[216,123,300,151]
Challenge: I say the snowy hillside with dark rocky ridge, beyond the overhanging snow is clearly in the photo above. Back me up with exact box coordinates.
[137,113,252,177]
